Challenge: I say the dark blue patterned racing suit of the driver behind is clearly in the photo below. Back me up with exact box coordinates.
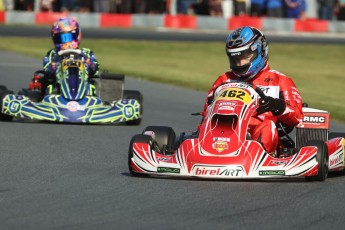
[29,48,99,95]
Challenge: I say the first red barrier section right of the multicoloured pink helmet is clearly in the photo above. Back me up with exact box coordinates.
[100,14,132,28]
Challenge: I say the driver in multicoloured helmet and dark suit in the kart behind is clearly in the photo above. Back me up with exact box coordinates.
[29,17,99,97]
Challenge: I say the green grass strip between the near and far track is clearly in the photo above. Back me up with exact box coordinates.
[0,37,345,122]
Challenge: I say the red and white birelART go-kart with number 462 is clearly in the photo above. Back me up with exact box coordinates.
[128,82,345,181]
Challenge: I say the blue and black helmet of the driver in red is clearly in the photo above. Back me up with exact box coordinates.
[225,26,268,81]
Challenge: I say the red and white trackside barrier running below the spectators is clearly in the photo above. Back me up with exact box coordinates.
[0,11,345,33]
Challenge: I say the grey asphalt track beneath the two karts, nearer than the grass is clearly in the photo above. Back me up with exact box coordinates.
[0,49,345,230]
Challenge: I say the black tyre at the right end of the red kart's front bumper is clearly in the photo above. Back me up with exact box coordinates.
[305,140,328,181]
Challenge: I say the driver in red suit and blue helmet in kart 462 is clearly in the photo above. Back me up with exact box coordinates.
[202,26,303,156]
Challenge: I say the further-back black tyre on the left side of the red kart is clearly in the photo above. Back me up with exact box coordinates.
[143,126,176,154]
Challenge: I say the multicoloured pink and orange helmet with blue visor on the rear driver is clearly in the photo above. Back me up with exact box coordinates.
[51,17,81,50]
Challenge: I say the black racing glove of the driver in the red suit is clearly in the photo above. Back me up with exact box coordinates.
[256,97,286,116]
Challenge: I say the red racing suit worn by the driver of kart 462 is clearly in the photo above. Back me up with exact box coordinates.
[202,64,303,153]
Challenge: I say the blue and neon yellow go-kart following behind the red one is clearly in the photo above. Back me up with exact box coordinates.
[0,50,143,125]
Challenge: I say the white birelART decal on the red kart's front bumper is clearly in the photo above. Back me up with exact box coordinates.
[193,166,244,177]
